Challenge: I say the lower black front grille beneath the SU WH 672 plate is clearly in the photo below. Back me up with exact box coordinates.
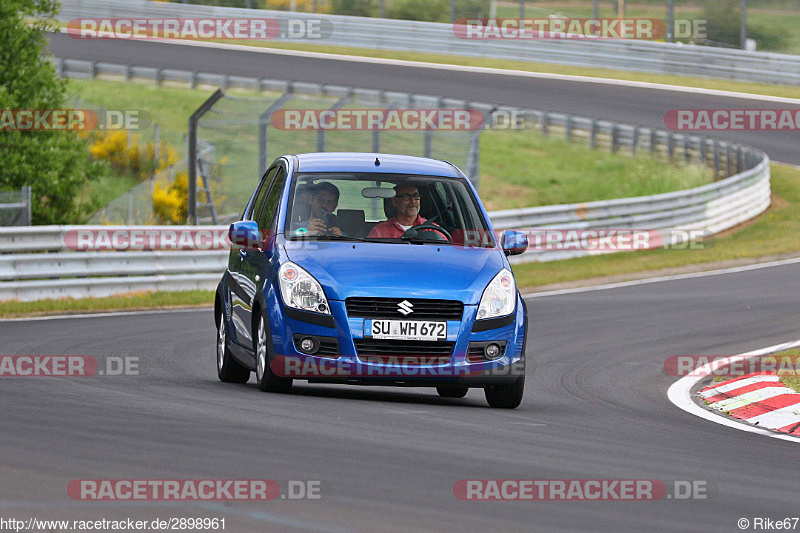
[355,339,455,365]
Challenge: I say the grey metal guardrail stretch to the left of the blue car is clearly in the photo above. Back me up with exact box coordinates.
[0,226,228,301]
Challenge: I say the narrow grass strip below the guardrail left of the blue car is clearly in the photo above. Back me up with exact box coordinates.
[0,290,214,318]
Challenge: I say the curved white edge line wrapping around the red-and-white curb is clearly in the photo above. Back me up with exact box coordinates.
[667,339,800,442]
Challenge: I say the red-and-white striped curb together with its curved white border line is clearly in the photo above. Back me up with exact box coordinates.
[667,340,800,442]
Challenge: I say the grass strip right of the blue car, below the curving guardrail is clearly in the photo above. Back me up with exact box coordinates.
[514,164,800,291]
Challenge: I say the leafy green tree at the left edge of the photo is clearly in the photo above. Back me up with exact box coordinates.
[0,0,102,224]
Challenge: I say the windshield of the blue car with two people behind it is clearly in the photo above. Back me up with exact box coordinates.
[285,173,495,248]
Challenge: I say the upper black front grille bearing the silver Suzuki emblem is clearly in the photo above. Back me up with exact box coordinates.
[345,298,464,320]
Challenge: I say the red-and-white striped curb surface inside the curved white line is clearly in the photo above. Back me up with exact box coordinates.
[700,372,800,435]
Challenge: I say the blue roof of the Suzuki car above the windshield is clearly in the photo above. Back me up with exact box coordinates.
[296,152,460,178]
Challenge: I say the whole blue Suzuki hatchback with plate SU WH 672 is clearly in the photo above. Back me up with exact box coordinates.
[214,152,528,409]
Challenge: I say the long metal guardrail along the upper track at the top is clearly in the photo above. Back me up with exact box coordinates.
[59,0,800,85]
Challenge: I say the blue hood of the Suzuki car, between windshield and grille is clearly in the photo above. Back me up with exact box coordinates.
[285,241,505,305]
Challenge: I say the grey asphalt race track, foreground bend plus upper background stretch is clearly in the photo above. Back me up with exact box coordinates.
[0,37,800,531]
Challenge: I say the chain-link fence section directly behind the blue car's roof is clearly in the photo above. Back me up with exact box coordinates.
[189,80,480,223]
